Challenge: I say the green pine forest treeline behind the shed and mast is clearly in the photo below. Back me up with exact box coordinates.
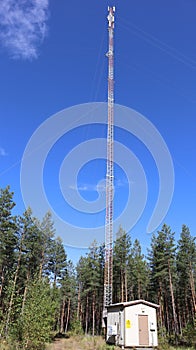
[0,186,196,349]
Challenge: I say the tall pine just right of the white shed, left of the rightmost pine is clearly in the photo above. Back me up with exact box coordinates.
[149,224,178,334]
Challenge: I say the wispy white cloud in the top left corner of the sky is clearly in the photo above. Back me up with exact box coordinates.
[0,0,49,59]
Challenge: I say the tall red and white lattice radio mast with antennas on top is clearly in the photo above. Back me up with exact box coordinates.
[103,7,115,318]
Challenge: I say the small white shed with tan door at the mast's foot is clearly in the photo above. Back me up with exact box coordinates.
[106,300,159,348]
